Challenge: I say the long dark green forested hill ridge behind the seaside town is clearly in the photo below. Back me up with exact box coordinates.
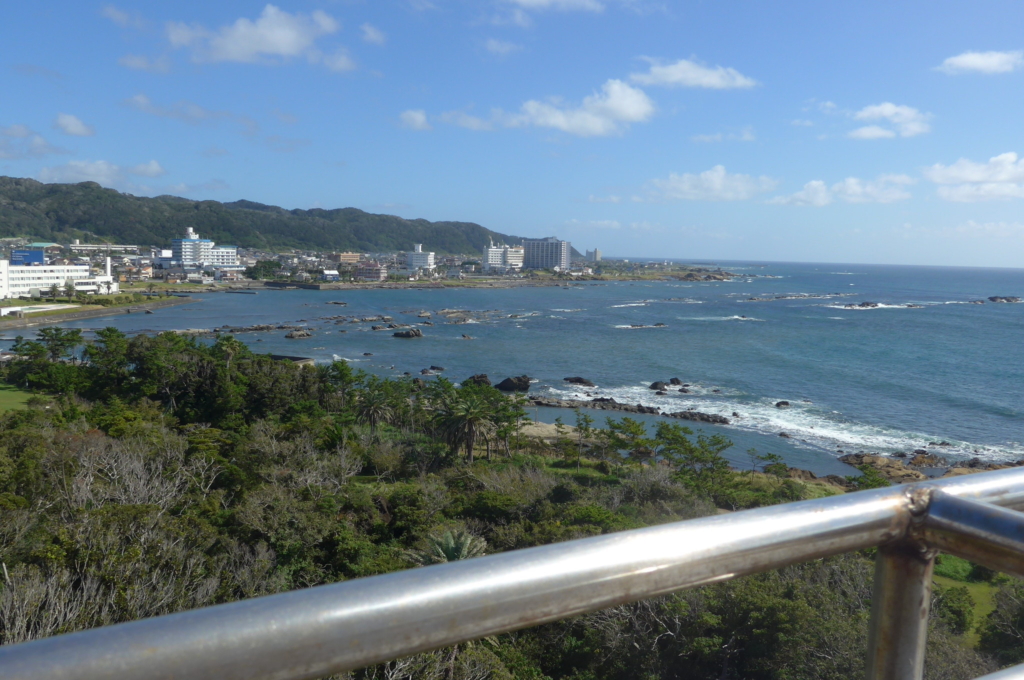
[0,176,521,253]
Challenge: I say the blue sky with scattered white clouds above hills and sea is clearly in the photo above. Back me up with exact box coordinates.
[0,0,1024,267]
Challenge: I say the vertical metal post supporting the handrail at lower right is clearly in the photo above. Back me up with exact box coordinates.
[866,542,935,680]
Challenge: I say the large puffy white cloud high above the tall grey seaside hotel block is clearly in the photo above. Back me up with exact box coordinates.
[506,80,654,137]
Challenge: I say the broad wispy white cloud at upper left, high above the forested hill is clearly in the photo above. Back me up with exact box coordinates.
[167,4,350,71]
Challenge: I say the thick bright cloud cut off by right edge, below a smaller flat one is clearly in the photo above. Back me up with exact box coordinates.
[925,152,1024,203]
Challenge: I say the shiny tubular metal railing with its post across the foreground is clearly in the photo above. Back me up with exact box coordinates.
[0,468,1024,680]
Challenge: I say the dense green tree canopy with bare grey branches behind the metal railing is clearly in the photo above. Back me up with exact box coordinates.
[0,328,1024,680]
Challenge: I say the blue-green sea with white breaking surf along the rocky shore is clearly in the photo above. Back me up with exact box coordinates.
[12,263,1024,472]
